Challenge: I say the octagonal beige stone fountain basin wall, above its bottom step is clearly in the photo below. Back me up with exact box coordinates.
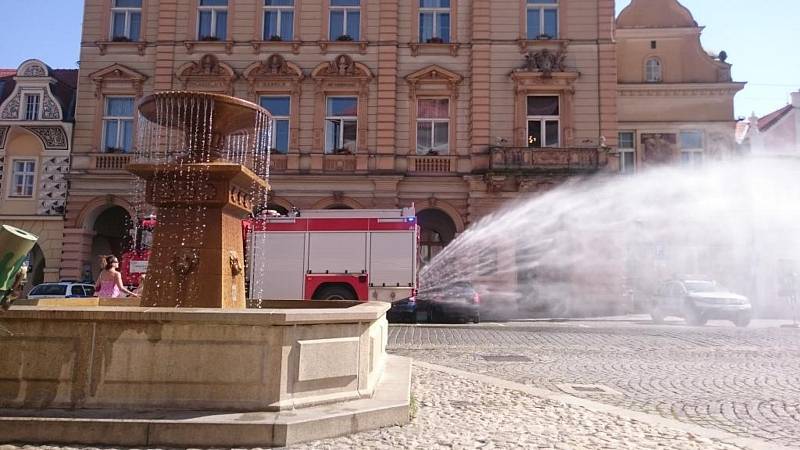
[0,301,389,412]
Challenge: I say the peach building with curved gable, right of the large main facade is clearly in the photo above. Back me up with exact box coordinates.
[615,0,744,172]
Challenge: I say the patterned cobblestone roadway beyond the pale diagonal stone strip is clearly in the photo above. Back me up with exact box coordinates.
[389,322,800,446]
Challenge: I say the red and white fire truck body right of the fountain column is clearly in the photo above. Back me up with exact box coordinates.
[244,207,418,302]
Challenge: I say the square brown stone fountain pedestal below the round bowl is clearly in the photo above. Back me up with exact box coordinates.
[128,162,269,309]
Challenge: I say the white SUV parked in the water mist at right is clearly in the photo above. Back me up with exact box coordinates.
[650,279,753,327]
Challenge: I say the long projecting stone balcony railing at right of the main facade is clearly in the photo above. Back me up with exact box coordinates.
[489,147,599,172]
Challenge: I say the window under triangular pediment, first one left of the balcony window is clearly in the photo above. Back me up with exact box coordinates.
[417,98,450,155]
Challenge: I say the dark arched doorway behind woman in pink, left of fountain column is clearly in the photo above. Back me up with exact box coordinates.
[92,206,133,276]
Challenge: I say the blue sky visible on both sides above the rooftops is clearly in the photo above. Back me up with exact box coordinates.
[0,0,800,117]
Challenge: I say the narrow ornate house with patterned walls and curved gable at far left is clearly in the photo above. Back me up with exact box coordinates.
[0,60,78,290]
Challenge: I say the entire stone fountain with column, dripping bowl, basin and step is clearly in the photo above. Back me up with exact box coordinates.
[0,92,410,447]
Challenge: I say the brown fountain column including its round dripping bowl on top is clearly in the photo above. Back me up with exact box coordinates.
[127,92,269,309]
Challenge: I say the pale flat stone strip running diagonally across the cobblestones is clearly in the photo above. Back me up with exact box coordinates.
[413,360,792,450]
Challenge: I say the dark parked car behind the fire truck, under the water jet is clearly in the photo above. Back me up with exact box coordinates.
[416,281,481,323]
